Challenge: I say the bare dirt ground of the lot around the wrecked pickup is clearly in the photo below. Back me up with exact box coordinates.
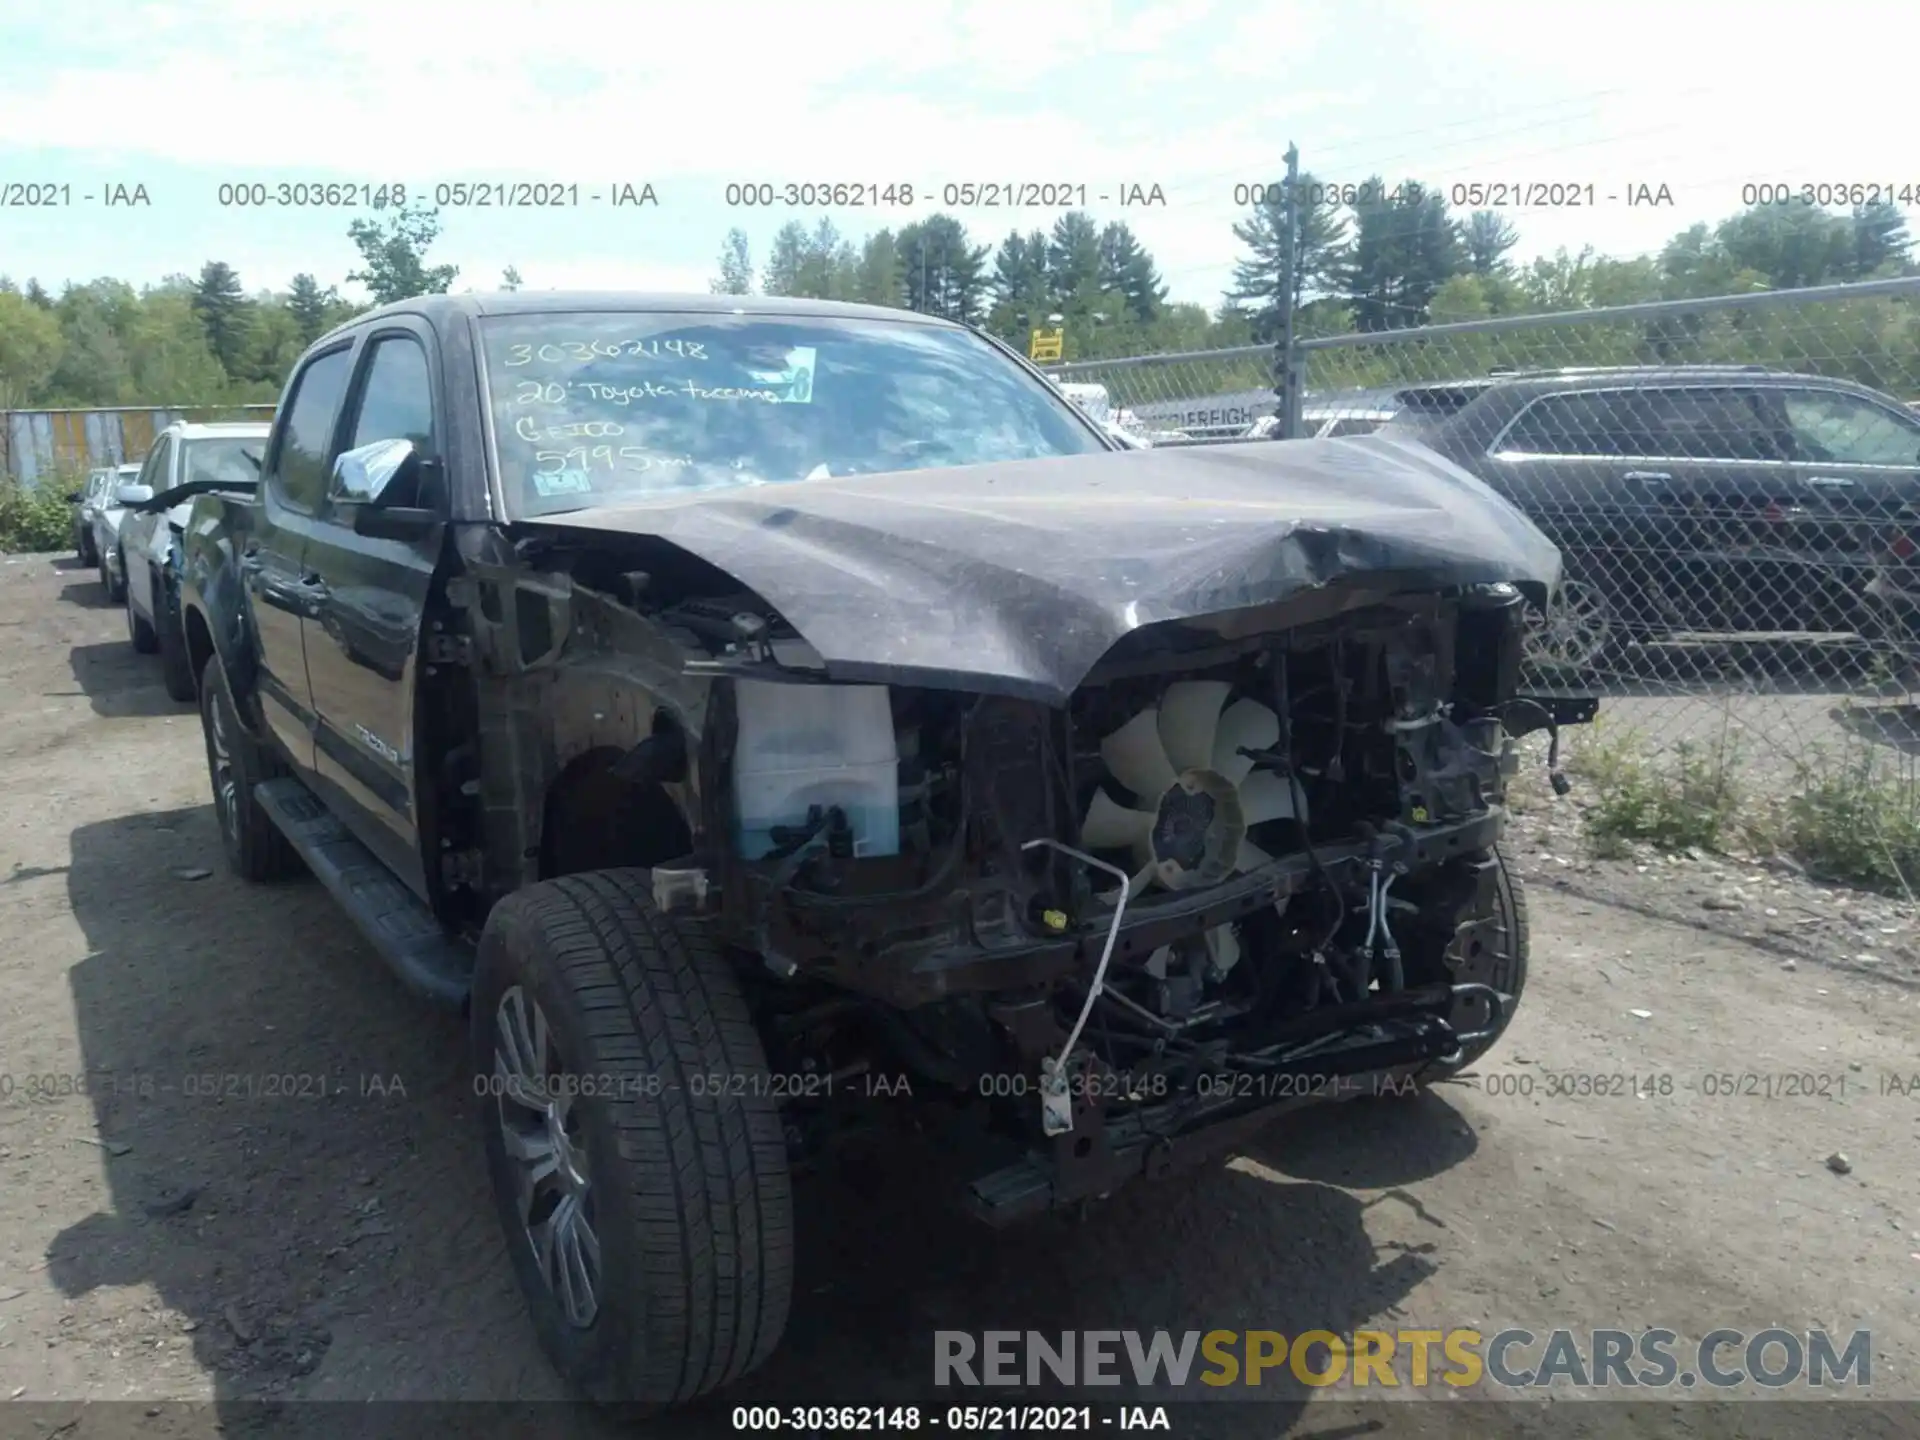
[0,557,1920,1436]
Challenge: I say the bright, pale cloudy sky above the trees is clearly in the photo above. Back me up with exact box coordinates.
[0,0,1920,305]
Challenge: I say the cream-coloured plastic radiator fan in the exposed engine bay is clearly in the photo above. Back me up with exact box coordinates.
[1081,680,1306,895]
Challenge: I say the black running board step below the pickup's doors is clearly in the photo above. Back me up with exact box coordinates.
[253,776,474,1010]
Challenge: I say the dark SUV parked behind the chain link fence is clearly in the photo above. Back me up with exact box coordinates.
[1405,365,1920,670]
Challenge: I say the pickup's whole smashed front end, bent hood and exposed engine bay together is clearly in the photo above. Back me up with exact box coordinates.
[456,442,1592,1223]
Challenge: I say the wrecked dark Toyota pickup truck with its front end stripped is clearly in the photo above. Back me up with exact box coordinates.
[182,294,1592,1405]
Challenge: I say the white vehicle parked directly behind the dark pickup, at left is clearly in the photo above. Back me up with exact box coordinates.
[119,420,269,701]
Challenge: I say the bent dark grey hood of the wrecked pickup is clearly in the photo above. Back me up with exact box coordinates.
[526,436,1559,705]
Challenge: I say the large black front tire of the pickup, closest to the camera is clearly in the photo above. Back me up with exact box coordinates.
[470,870,793,1409]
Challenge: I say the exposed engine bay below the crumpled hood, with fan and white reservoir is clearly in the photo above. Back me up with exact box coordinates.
[599,586,1559,1213]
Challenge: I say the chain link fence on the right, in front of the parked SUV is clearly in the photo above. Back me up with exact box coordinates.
[1052,278,1920,883]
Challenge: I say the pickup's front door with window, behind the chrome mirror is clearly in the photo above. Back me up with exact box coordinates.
[305,319,447,899]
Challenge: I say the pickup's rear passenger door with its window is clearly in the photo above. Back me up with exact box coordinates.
[247,340,353,774]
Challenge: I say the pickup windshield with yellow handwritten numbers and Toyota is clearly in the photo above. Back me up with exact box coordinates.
[480,313,1108,518]
